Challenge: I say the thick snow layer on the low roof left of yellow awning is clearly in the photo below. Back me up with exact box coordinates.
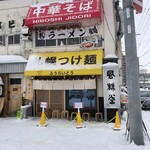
[0,55,27,64]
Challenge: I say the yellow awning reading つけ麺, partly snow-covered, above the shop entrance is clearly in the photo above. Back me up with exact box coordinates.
[25,50,103,76]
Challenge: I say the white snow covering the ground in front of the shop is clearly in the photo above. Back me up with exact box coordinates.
[0,111,150,150]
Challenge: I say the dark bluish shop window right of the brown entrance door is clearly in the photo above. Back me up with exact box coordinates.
[66,90,96,108]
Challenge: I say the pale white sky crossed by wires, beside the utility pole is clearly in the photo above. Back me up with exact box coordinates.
[121,0,150,71]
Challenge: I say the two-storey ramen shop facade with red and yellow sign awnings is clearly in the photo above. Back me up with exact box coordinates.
[2,0,122,117]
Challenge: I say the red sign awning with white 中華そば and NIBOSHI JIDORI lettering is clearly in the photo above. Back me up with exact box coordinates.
[25,0,102,26]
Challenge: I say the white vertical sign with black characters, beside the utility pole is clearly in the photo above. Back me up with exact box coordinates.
[103,63,120,108]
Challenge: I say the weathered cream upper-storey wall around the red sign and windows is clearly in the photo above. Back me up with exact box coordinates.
[0,0,116,57]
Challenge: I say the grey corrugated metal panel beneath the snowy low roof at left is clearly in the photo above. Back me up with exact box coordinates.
[0,63,26,73]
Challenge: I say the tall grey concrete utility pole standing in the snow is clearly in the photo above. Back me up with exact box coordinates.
[123,0,144,145]
